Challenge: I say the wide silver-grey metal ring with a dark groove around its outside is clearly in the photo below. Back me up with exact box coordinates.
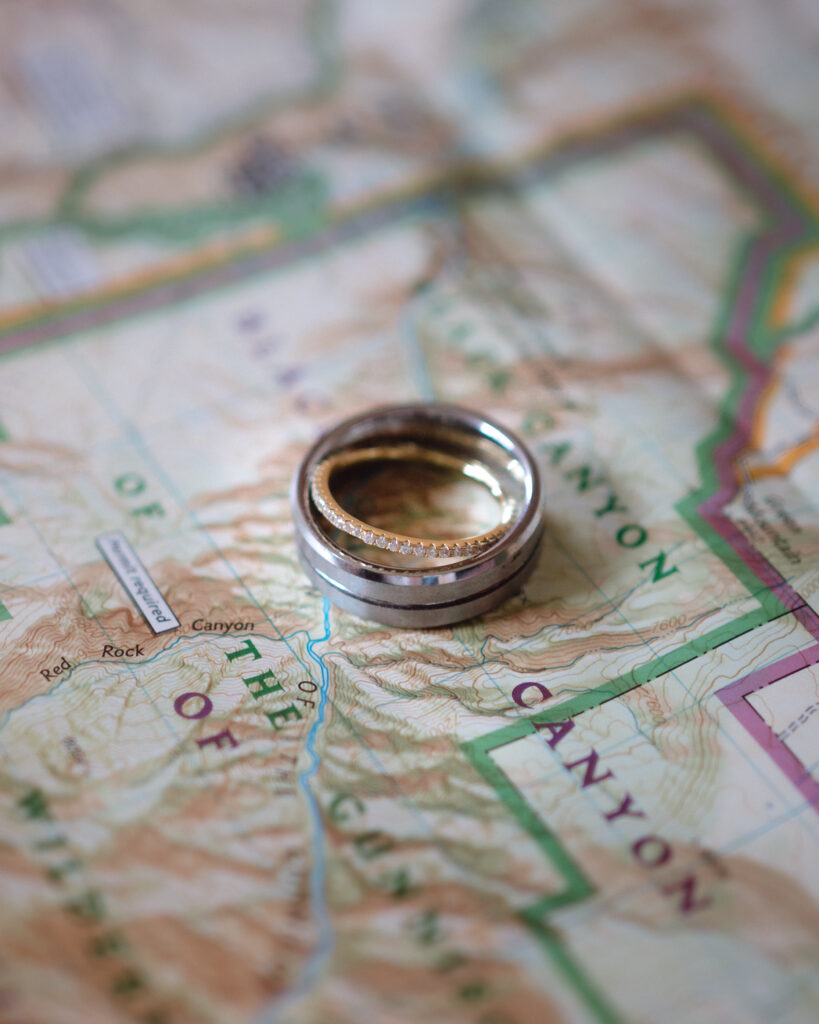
[291,402,543,629]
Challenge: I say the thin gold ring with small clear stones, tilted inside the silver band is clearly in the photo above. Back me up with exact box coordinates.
[310,443,517,558]
